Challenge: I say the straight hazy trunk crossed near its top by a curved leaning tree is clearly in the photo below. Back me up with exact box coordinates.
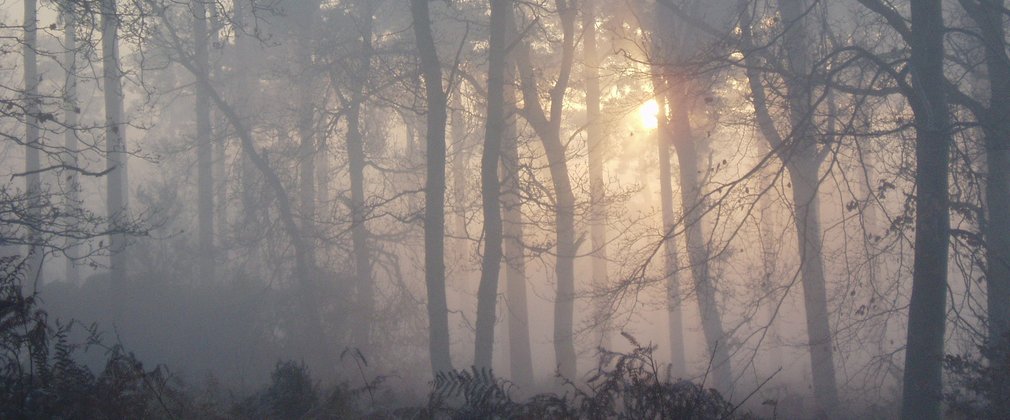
[191,0,214,283]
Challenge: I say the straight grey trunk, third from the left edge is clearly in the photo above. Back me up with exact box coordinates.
[101,0,129,318]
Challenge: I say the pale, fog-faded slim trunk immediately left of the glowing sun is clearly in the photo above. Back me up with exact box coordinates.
[582,0,610,346]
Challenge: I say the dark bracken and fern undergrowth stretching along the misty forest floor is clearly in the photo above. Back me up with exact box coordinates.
[0,257,749,419]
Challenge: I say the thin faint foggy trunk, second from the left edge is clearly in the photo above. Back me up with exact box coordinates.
[61,1,81,285]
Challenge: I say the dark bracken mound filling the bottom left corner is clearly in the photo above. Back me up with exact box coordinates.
[0,257,178,419]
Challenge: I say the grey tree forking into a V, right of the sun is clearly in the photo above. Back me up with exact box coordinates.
[740,0,838,413]
